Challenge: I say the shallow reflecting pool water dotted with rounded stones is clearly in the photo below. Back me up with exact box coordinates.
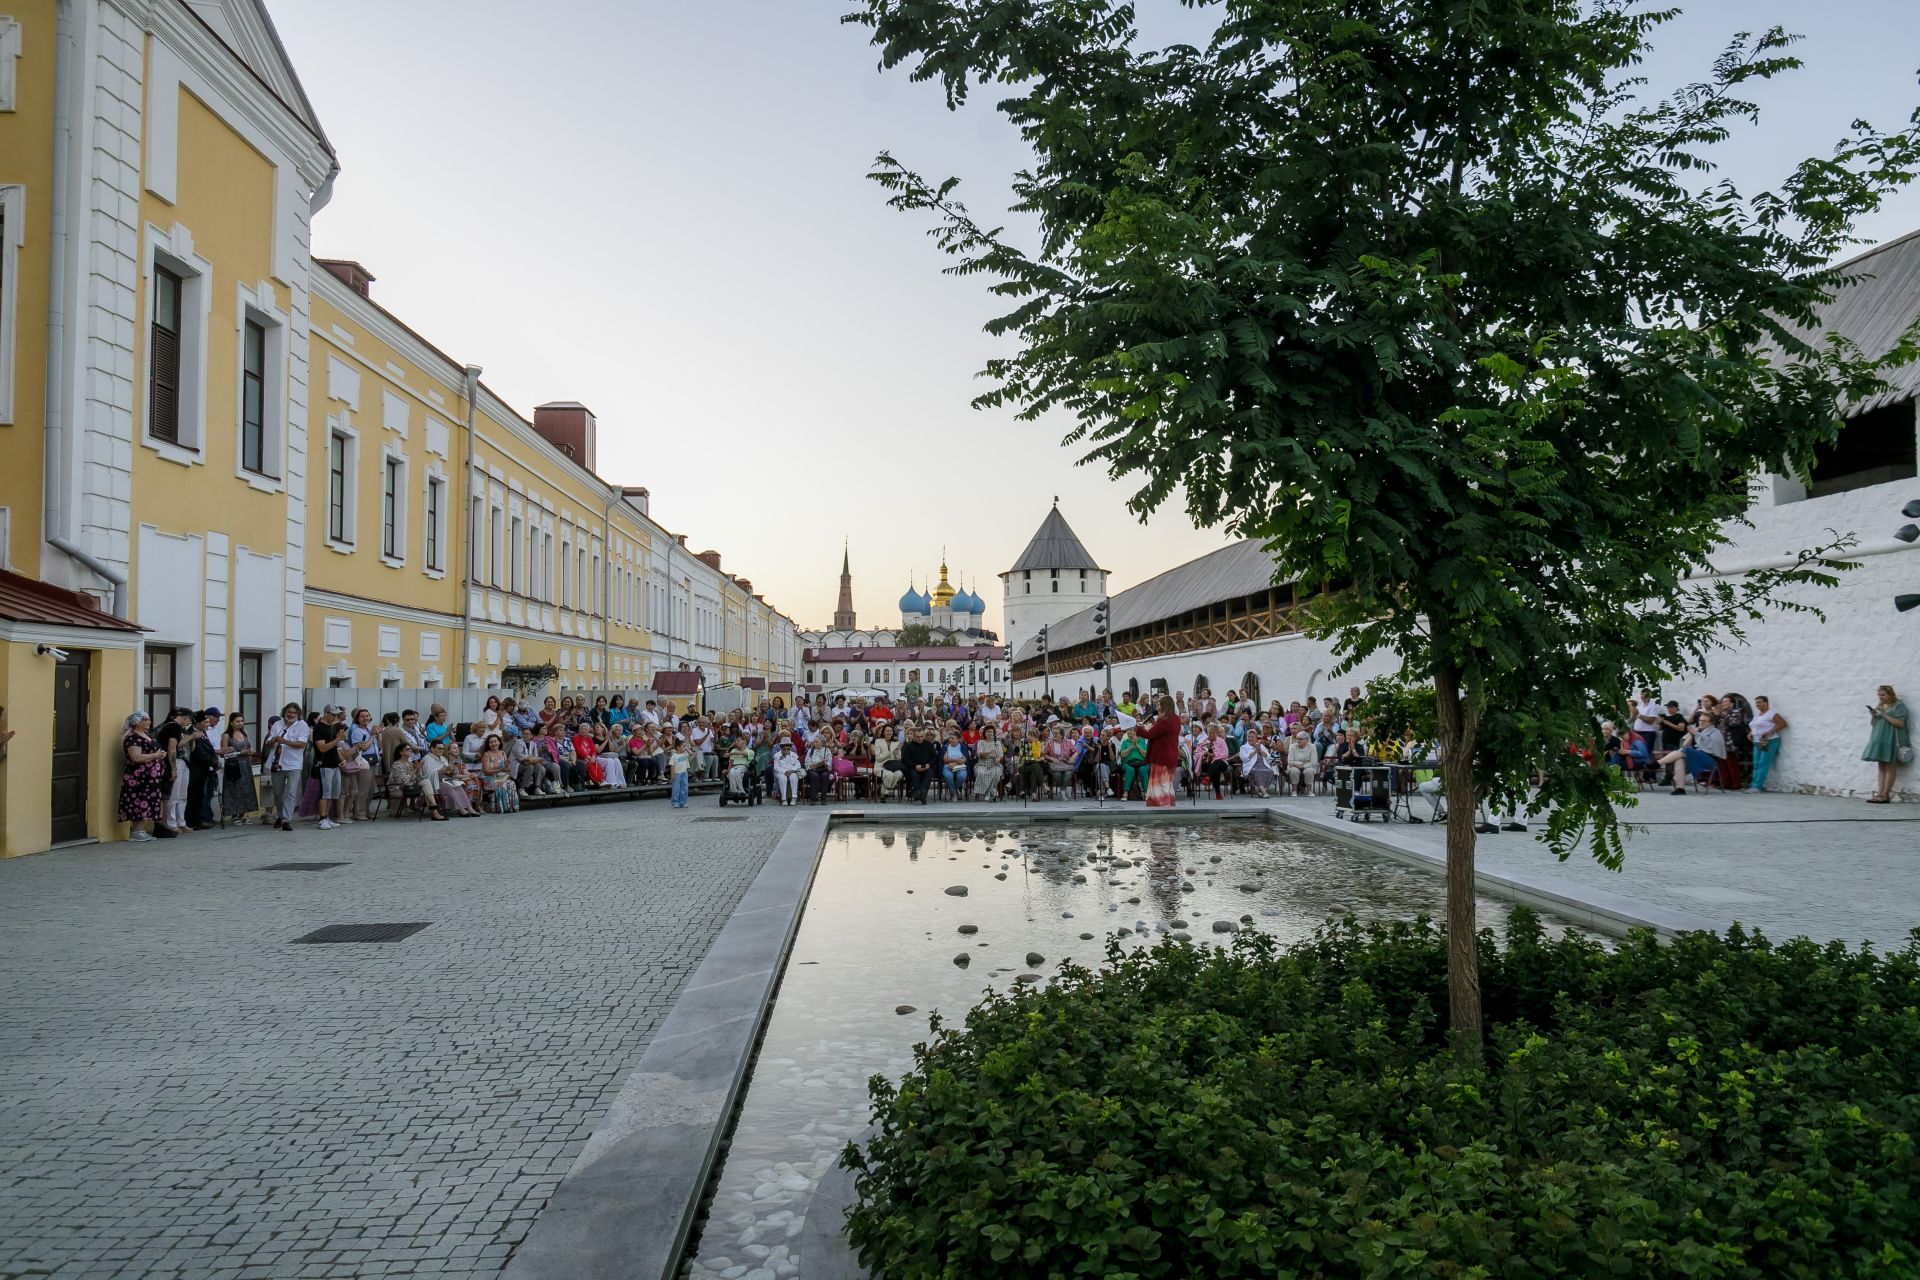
[687,821,1563,1280]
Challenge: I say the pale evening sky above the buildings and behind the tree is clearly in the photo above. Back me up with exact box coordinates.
[269,0,1920,628]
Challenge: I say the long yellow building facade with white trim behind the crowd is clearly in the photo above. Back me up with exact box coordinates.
[0,0,799,854]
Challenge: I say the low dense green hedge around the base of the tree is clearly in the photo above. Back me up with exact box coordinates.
[847,912,1920,1280]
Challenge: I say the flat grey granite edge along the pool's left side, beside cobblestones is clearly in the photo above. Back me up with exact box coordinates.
[501,814,831,1280]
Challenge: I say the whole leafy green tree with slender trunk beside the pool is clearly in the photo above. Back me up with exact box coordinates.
[847,0,1920,1054]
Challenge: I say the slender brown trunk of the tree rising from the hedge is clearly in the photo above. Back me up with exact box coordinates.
[1434,664,1480,1063]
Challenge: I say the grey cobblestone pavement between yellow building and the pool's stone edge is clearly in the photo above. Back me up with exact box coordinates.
[0,800,791,1280]
